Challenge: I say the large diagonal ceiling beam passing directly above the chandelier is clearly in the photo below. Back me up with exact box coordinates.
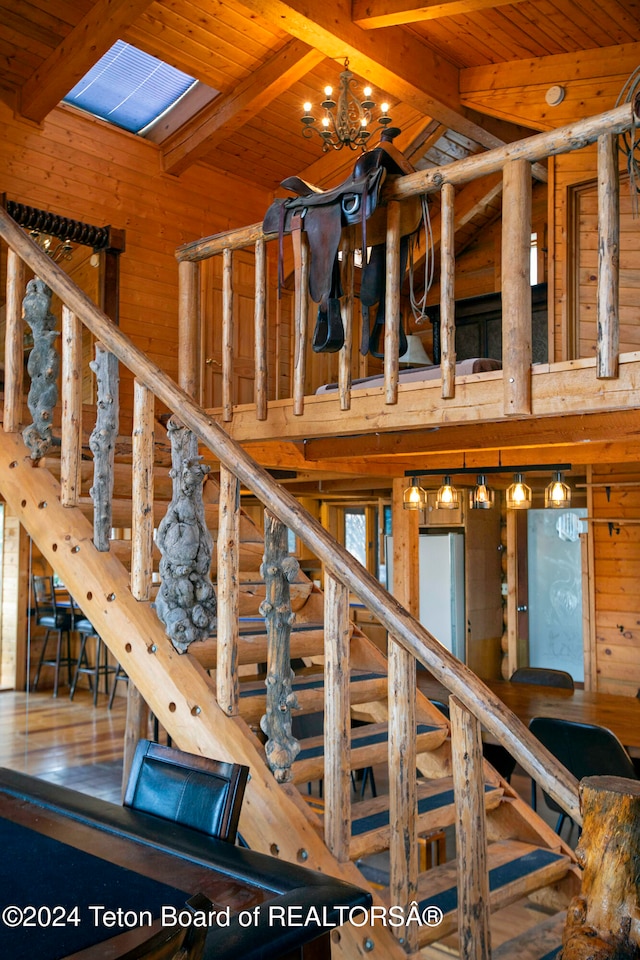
[235,0,510,149]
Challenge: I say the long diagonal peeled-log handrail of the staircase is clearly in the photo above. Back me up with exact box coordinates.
[0,204,580,822]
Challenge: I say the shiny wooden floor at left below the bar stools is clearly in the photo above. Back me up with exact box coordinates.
[0,689,126,803]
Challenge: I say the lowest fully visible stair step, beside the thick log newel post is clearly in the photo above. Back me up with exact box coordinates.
[382,840,571,947]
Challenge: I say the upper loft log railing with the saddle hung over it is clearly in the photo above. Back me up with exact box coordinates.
[176,103,633,422]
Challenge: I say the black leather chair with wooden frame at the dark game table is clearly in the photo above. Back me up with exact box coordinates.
[124,740,249,843]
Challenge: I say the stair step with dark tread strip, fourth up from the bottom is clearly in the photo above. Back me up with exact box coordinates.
[291,720,447,788]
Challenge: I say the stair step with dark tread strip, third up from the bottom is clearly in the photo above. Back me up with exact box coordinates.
[349,777,504,860]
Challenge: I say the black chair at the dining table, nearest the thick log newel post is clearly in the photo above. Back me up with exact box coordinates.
[529,717,638,833]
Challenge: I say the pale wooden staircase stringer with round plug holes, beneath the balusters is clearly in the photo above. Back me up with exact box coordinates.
[0,430,407,960]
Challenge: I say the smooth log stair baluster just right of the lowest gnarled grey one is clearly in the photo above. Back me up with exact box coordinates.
[324,574,351,862]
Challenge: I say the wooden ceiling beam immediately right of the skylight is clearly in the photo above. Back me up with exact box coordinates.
[162,39,324,174]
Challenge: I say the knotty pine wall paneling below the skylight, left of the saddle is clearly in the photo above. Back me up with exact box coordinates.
[0,103,270,424]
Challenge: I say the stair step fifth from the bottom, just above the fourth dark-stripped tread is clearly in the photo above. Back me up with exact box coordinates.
[240,670,387,724]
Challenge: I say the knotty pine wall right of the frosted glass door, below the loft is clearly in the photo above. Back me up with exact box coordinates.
[591,463,640,696]
